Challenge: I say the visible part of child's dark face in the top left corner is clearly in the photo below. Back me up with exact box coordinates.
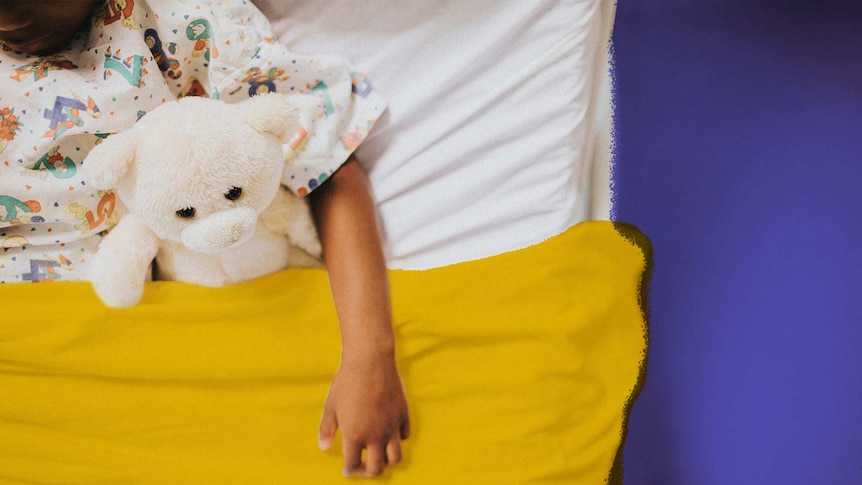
[0,0,105,55]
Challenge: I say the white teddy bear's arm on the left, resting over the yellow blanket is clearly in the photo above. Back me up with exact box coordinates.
[89,214,160,308]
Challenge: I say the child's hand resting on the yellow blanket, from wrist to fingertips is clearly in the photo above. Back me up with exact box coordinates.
[320,359,410,477]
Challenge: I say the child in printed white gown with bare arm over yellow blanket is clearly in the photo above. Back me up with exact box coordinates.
[0,0,408,476]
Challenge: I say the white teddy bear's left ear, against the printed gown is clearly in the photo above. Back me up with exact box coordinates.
[83,132,137,190]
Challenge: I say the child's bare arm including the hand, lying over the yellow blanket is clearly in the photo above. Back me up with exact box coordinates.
[310,157,409,476]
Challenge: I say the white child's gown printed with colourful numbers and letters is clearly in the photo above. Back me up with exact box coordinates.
[0,0,385,283]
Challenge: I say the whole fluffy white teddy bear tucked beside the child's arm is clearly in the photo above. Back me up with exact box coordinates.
[82,93,321,308]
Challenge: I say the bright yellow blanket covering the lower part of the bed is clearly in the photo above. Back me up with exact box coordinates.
[0,222,649,485]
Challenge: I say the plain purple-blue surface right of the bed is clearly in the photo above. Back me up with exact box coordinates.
[614,0,862,485]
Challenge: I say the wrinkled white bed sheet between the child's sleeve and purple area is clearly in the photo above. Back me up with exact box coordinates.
[255,0,615,269]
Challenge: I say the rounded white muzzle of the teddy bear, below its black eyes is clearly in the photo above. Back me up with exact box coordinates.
[180,207,257,253]
